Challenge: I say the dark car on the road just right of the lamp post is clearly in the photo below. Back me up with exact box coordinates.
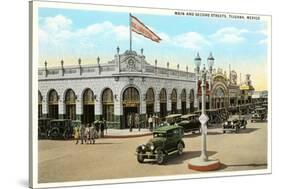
[222,115,247,133]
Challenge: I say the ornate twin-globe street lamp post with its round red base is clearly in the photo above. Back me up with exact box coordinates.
[188,53,220,171]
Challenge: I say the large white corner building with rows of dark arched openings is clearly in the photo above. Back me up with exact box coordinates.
[38,48,197,129]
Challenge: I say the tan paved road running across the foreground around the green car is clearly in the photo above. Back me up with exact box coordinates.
[38,121,267,183]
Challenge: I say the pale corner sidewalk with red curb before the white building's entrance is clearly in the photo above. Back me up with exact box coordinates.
[104,128,152,138]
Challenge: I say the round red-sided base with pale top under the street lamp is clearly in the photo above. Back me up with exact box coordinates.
[188,158,221,171]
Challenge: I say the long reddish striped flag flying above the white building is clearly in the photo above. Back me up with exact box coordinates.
[130,14,161,43]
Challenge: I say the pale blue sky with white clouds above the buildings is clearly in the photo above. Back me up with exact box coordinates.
[39,8,267,90]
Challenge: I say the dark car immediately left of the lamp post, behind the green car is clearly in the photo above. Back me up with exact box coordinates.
[177,114,201,133]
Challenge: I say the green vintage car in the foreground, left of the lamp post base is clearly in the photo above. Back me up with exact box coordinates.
[136,125,185,165]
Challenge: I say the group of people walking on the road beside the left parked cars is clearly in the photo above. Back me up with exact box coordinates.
[74,119,107,144]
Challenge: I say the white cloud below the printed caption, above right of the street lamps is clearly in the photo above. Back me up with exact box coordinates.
[210,27,249,44]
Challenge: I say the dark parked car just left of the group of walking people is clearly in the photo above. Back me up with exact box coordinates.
[49,119,73,140]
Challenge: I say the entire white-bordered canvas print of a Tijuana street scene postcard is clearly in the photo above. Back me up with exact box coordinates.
[29,1,271,188]
